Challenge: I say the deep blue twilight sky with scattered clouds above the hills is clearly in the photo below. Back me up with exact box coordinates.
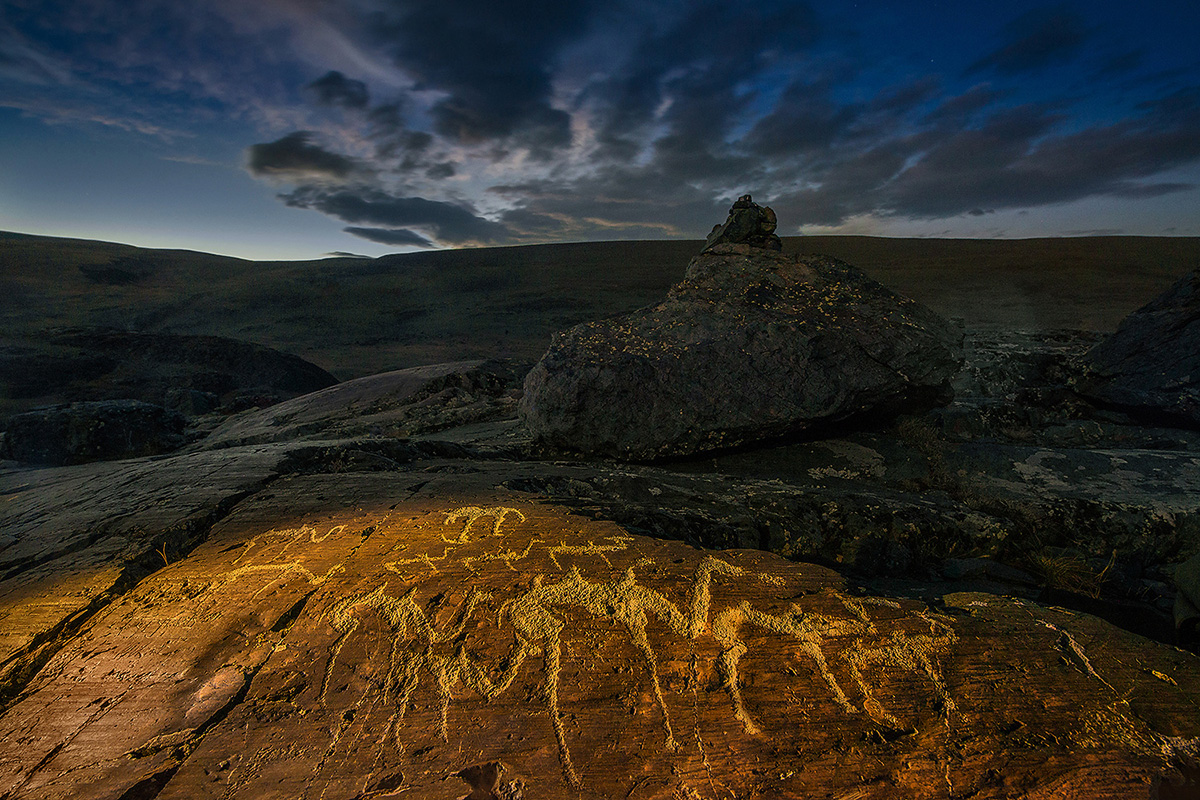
[0,0,1200,259]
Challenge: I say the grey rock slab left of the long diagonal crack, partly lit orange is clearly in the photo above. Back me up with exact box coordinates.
[0,447,286,705]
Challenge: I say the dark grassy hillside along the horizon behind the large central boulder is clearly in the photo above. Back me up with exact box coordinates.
[0,234,1200,379]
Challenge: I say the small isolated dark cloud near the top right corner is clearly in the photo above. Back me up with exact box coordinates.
[967,5,1090,74]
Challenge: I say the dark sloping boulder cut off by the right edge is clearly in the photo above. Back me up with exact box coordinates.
[1080,271,1200,427]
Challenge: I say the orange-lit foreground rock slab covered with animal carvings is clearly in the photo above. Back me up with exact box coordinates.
[0,464,1200,800]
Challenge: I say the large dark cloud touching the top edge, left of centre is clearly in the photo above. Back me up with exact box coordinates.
[374,0,601,149]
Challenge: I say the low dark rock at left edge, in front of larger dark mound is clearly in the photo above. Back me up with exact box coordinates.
[2,401,184,464]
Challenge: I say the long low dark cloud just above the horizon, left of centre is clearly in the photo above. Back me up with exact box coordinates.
[280,186,511,245]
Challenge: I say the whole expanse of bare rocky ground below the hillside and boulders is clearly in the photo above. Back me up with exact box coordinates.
[0,227,1200,800]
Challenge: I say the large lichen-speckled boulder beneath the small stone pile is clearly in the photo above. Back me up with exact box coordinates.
[520,245,961,459]
